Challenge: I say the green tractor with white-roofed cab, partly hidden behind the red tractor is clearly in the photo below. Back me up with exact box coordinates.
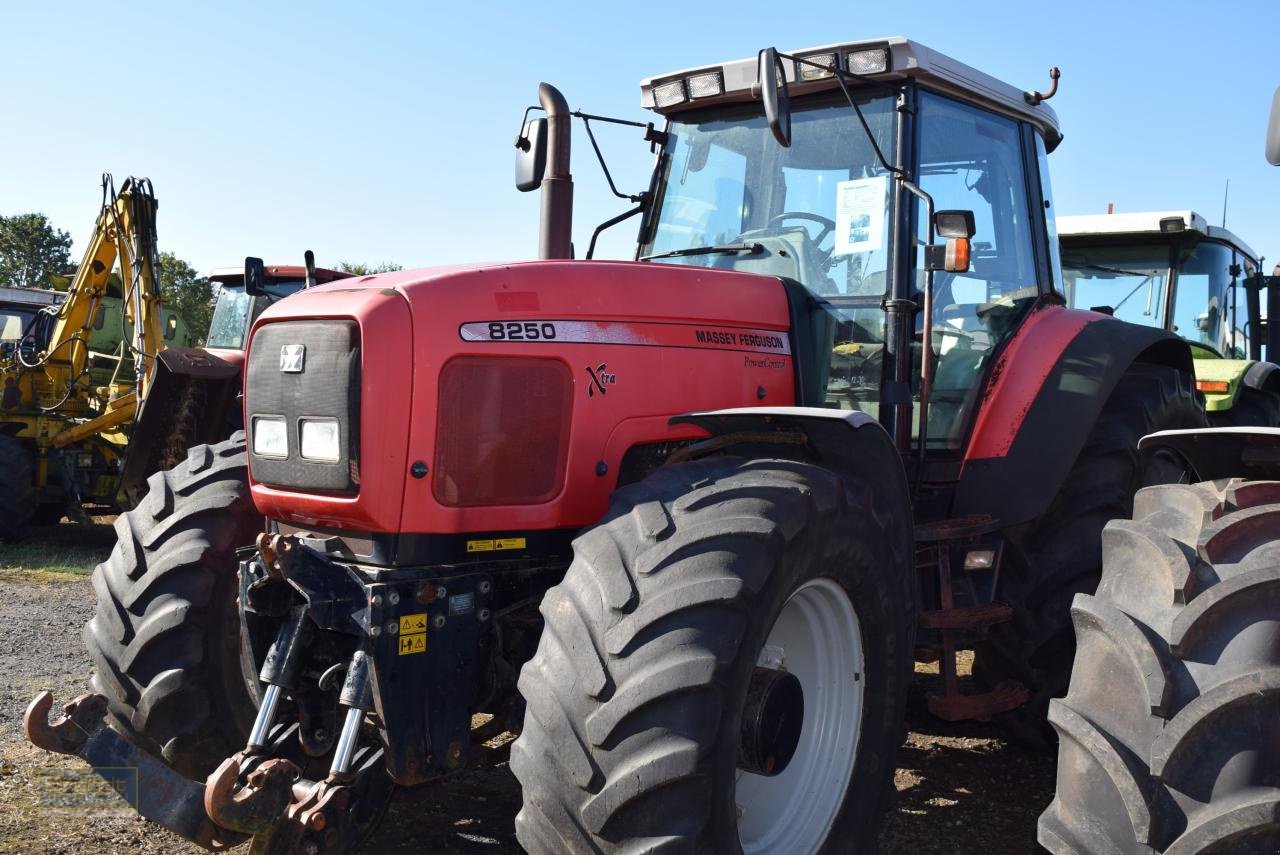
[1057,211,1280,426]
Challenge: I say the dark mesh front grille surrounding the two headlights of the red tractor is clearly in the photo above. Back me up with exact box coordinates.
[244,320,360,493]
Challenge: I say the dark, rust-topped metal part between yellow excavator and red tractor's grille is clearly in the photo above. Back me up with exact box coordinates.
[116,347,243,508]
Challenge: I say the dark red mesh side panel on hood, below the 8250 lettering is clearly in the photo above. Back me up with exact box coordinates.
[431,356,573,507]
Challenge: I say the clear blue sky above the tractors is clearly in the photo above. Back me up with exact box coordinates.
[0,0,1280,270]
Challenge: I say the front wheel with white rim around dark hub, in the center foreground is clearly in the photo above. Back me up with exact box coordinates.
[511,458,915,854]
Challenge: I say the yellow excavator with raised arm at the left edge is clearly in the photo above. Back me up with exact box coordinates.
[0,174,166,540]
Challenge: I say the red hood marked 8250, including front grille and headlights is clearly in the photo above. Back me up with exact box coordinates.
[244,261,795,532]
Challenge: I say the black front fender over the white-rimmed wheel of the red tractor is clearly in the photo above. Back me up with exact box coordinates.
[671,407,911,535]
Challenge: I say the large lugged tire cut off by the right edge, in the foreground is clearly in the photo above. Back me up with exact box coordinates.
[1038,481,1280,855]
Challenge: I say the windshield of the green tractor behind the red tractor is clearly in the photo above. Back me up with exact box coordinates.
[1062,245,1169,328]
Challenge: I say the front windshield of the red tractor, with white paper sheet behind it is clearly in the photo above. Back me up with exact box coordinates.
[640,92,895,294]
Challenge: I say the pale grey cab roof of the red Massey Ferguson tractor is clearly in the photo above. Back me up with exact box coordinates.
[640,36,1062,150]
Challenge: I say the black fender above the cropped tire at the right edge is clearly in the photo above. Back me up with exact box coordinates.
[1138,428,1280,481]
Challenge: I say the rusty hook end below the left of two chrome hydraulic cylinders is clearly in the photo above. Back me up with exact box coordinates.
[205,749,302,835]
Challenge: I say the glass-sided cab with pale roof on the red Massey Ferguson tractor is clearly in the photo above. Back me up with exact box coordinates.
[636,38,1061,452]
